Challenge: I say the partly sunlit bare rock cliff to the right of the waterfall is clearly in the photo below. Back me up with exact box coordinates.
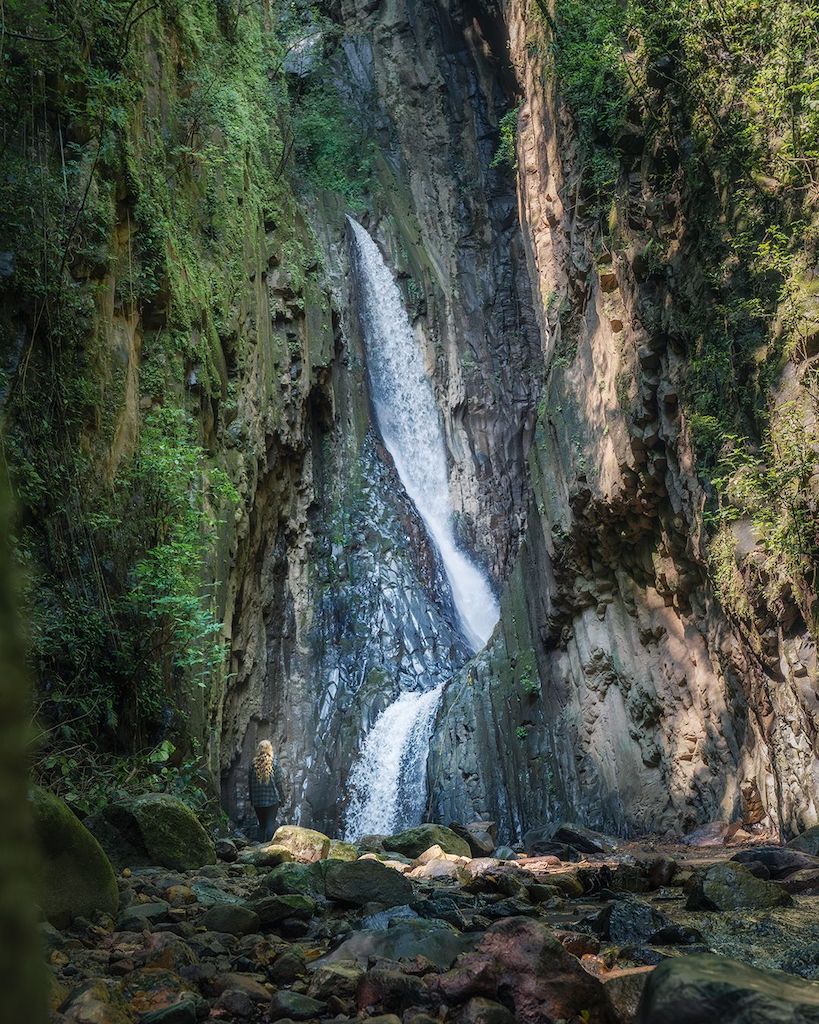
[430,3,817,835]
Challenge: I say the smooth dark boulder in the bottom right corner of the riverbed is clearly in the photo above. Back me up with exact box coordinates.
[637,953,819,1024]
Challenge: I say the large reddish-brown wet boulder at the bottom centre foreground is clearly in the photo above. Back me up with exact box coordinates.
[435,918,605,1024]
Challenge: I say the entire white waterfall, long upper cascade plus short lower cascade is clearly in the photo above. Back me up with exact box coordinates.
[339,218,500,840]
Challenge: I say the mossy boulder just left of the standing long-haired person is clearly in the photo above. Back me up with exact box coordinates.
[89,793,216,871]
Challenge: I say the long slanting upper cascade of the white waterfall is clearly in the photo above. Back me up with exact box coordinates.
[348,218,500,650]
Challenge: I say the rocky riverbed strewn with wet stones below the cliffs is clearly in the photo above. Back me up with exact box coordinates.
[40,799,819,1024]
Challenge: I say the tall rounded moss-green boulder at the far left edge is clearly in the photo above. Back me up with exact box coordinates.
[32,786,120,928]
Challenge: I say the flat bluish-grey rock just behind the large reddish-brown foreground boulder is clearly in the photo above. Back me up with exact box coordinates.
[317,919,477,970]
